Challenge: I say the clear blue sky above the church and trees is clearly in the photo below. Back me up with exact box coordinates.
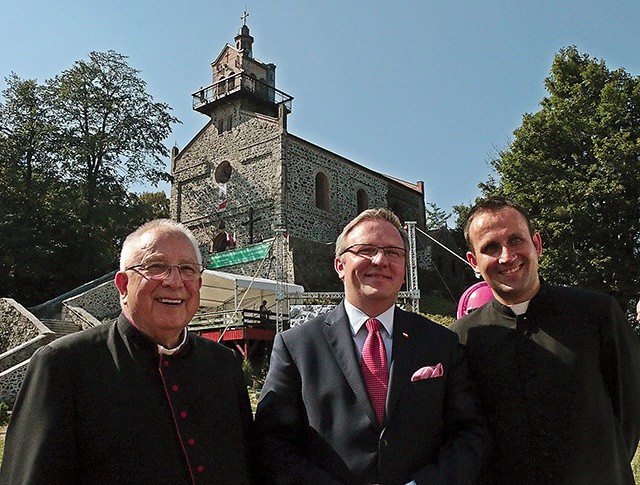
[0,0,640,221]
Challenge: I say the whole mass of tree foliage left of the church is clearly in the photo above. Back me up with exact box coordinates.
[0,51,177,306]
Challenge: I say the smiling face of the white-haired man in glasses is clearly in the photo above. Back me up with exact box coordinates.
[115,229,202,348]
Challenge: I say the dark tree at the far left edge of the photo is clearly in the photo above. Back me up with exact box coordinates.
[0,74,77,303]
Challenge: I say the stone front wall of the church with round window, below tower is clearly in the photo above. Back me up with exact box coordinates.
[171,112,281,245]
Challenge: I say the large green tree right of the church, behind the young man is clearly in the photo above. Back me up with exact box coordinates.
[480,47,640,301]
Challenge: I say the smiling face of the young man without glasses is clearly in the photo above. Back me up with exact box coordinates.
[467,207,542,305]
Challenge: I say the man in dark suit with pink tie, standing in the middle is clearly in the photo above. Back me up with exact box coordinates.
[256,209,490,484]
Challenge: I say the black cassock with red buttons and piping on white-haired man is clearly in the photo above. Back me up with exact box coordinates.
[0,315,252,485]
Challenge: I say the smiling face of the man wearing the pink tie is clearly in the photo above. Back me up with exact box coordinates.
[334,219,406,316]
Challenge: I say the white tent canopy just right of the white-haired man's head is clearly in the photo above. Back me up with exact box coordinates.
[200,269,304,310]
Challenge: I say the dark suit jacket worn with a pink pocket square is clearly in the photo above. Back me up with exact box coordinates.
[256,303,489,484]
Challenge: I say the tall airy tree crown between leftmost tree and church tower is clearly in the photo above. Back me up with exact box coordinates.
[47,51,179,217]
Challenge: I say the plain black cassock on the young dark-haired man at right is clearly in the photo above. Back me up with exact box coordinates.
[453,282,640,485]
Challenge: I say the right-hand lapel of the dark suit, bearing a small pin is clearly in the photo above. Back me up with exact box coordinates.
[387,308,418,416]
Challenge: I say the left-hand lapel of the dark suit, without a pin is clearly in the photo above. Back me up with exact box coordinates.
[323,303,379,426]
